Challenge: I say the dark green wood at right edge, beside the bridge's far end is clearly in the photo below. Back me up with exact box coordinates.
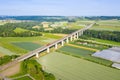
[84,30,120,42]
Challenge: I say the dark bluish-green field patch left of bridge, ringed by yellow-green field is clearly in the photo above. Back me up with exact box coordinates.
[12,42,42,51]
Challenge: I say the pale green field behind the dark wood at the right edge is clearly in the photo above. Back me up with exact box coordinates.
[90,20,120,31]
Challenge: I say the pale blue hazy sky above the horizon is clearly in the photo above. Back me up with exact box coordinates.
[0,0,120,16]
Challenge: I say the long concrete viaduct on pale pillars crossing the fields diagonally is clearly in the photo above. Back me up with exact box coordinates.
[0,23,95,71]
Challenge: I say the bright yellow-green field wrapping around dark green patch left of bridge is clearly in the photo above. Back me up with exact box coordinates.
[0,33,63,54]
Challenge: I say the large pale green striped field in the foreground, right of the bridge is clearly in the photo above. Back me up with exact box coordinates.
[37,52,120,80]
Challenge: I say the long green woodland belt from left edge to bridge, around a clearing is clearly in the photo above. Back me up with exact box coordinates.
[0,22,76,37]
